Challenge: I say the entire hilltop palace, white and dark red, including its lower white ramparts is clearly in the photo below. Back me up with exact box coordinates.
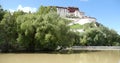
[56,6,96,25]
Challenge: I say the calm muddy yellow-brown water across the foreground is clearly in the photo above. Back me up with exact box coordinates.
[0,51,120,63]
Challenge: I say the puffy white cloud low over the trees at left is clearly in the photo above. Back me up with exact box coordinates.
[9,5,37,13]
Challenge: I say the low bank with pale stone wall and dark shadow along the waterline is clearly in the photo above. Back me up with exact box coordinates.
[0,46,120,54]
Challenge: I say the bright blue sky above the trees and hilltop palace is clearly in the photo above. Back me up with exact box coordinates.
[0,0,120,34]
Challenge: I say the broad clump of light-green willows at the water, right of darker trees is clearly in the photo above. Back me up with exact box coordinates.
[17,13,74,51]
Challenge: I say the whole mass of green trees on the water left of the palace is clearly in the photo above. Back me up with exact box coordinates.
[0,7,75,52]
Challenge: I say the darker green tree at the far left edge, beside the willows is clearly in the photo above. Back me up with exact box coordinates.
[0,11,25,52]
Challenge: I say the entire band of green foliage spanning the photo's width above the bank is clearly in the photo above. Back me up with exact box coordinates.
[0,6,120,52]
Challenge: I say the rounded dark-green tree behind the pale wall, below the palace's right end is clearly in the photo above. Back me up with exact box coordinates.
[81,28,105,46]
